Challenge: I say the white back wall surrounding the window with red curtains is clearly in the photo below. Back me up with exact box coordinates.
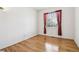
[38,7,75,39]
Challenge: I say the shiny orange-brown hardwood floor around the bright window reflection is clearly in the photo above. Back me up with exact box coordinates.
[2,35,79,52]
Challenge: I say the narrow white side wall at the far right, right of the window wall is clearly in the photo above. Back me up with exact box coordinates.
[75,8,79,47]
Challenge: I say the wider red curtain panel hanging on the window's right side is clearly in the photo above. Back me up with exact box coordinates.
[56,10,62,36]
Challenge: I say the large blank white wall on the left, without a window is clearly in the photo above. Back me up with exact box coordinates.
[0,7,37,49]
